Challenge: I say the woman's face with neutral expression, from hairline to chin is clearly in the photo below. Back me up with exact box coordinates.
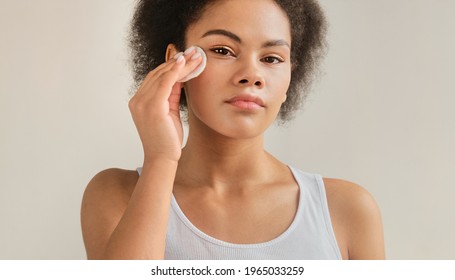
[185,0,291,139]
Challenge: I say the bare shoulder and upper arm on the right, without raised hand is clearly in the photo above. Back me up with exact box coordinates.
[324,178,385,259]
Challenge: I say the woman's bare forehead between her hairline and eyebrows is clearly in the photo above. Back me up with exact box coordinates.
[187,0,291,44]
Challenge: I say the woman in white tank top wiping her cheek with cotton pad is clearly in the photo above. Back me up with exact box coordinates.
[81,0,384,259]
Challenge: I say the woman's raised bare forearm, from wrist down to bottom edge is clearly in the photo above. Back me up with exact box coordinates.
[104,160,177,259]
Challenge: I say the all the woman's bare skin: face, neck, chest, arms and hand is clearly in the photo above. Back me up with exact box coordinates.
[81,0,385,259]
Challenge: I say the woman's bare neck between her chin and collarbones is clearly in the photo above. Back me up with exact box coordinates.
[177,124,278,190]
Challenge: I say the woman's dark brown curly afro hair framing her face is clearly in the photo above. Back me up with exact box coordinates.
[129,0,327,122]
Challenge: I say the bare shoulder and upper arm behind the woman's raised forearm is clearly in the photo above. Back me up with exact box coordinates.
[81,168,139,259]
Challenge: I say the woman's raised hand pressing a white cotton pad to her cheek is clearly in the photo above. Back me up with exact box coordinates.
[128,48,202,162]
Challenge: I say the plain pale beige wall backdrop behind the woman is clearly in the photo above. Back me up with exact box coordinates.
[0,0,455,259]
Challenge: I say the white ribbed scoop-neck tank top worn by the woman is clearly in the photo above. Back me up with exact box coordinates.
[138,167,341,260]
